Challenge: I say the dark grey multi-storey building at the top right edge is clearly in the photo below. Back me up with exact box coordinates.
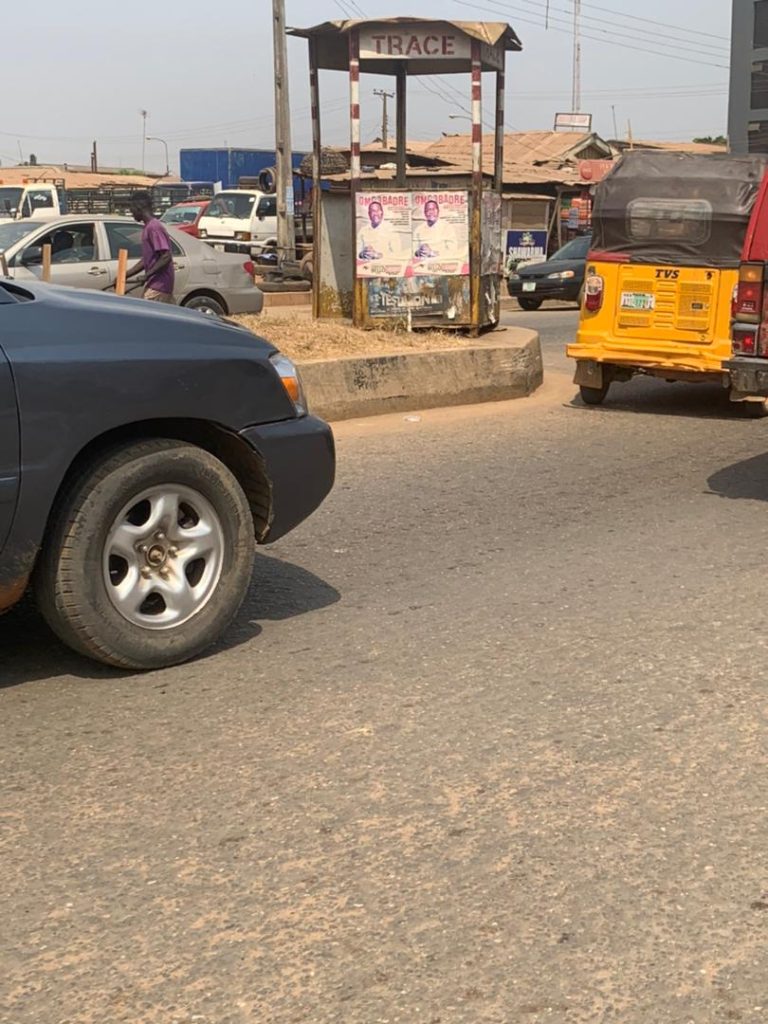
[728,0,768,154]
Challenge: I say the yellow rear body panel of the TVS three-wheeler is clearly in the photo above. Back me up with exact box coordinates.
[566,260,738,376]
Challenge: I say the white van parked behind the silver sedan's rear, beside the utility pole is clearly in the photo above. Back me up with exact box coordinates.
[198,188,278,256]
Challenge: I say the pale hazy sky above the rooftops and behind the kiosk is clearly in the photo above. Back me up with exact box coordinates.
[0,0,731,176]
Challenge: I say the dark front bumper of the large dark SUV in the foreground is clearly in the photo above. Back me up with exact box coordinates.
[241,416,336,544]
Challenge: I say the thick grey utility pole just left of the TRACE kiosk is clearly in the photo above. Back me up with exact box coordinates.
[272,0,296,260]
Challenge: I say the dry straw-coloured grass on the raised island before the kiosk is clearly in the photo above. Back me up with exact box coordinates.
[232,313,472,362]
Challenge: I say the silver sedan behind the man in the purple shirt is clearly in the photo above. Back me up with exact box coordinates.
[0,214,264,315]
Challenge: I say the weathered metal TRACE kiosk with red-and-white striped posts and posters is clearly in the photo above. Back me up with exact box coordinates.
[291,17,522,336]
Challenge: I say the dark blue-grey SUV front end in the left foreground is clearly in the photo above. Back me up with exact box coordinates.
[0,279,335,669]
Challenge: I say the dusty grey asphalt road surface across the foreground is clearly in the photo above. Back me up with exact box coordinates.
[0,309,768,1024]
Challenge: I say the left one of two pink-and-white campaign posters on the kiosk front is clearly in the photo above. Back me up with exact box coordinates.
[355,191,411,278]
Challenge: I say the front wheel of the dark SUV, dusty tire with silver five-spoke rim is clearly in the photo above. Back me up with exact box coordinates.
[34,439,255,670]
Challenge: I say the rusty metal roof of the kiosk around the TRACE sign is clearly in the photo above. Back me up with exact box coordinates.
[288,17,522,75]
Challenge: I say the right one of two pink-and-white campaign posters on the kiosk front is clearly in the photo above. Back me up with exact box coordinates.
[411,191,469,276]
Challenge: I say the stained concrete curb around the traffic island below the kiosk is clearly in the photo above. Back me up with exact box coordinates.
[299,328,544,420]
